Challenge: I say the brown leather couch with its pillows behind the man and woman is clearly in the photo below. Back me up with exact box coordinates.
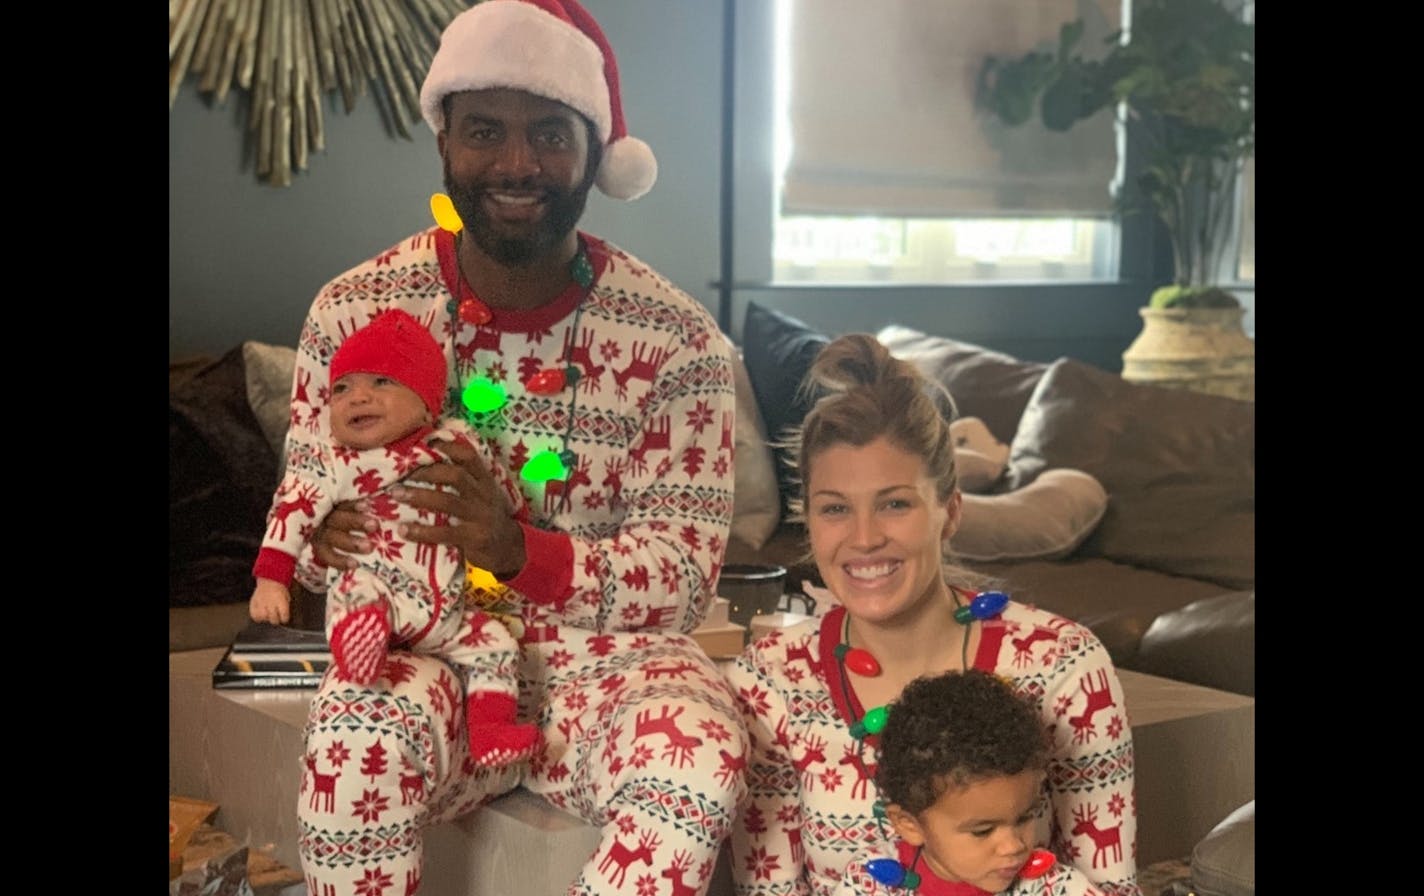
[169,303,1255,695]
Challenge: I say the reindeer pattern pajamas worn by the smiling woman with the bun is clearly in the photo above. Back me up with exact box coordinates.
[728,601,1141,896]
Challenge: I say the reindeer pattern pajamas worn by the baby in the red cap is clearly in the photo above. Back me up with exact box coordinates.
[253,420,524,695]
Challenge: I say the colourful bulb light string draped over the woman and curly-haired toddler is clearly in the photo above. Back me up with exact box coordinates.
[833,588,1057,890]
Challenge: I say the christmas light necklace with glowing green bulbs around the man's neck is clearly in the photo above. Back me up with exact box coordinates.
[430,192,594,495]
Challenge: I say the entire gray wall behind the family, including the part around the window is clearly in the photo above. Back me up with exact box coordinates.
[168,0,1255,370]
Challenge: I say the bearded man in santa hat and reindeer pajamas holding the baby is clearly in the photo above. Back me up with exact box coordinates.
[288,0,746,896]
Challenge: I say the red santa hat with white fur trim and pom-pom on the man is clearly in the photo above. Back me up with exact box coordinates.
[420,0,658,199]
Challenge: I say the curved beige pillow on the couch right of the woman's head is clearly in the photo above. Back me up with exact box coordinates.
[950,469,1108,561]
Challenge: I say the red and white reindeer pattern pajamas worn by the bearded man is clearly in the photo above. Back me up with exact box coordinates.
[288,228,746,896]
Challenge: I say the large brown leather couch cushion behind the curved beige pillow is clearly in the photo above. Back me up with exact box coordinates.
[1002,358,1256,590]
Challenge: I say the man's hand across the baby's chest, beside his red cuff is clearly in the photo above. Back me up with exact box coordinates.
[395,442,524,578]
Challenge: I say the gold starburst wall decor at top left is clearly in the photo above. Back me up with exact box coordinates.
[168,0,471,187]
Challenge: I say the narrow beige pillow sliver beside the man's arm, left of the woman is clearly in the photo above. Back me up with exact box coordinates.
[728,339,782,550]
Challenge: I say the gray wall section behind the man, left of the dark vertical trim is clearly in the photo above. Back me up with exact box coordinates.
[168,0,722,360]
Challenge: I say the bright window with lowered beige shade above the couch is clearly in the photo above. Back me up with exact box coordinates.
[772,0,1119,283]
